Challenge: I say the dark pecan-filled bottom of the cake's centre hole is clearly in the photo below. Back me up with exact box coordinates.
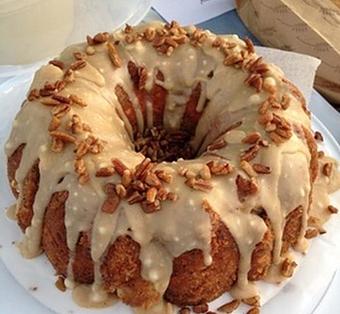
[134,127,195,162]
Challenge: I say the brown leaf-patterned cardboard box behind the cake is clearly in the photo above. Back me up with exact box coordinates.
[236,0,340,106]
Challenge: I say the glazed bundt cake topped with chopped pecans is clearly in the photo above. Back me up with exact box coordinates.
[6,22,340,313]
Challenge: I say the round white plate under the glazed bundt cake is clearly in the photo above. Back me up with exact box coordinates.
[0,73,340,314]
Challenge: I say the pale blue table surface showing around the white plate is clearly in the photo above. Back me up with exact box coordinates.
[0,7,340,314]
